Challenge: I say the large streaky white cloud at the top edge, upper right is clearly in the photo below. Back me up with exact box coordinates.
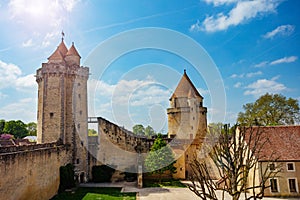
[196,0,280,32]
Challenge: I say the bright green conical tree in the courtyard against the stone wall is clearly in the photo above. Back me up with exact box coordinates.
[145,134,176,182]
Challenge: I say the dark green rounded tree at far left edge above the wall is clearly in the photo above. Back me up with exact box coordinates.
[3,120,28,138]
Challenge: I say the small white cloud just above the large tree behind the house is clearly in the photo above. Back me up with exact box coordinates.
[244,76,287,98]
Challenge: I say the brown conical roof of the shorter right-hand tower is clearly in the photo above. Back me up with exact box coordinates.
[171,70,203,99]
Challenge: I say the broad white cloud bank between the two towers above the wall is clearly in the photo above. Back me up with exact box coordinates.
[88,77,171,128]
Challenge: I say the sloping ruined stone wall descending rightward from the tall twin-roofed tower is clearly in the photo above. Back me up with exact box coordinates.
[96,117,153,171]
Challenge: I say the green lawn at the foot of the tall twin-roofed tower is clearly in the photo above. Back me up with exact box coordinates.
[52,188,136,200]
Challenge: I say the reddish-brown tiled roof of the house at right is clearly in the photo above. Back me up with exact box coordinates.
[246,126,300,161]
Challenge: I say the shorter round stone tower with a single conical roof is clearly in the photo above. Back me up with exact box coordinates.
[167,70,207,178]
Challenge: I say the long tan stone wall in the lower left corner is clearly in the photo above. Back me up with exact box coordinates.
[0,143,71,200]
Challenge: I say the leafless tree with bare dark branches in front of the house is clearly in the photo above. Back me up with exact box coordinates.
[189,125,280,200]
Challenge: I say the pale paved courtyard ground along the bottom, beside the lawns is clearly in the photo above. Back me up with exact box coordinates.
[80,182,299,200]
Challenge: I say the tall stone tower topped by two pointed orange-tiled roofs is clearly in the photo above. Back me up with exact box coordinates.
[36,38,89,178]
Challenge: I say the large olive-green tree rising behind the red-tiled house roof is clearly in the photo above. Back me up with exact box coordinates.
[237,93,300,126]
